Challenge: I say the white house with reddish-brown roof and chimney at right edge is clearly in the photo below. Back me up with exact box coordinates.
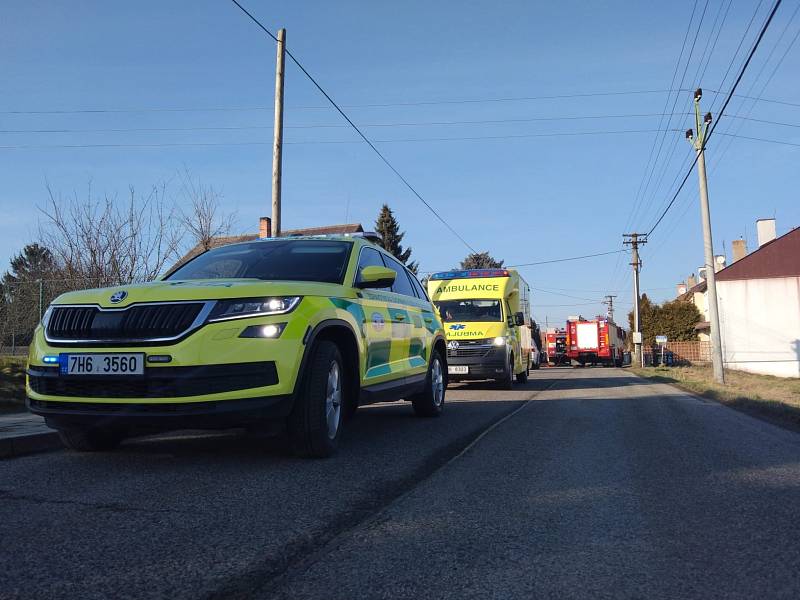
[717,225,800,377]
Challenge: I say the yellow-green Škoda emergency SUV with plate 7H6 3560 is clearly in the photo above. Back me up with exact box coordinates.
[27,236,447,457]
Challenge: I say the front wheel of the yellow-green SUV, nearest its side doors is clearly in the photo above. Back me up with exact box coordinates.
[288,340,345,458]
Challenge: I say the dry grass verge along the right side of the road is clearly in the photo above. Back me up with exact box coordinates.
[631,366,800,431]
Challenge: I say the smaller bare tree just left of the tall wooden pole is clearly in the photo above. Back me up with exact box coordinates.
[181,170,236,250]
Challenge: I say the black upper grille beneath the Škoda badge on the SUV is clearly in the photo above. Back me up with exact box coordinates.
[47,302,204,343]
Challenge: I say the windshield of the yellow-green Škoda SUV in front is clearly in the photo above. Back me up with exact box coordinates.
[167,240,352,283]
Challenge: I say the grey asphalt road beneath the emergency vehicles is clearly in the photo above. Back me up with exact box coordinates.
[0,369,800,599]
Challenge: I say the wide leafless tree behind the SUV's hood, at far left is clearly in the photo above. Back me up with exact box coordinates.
[40,184,184,289]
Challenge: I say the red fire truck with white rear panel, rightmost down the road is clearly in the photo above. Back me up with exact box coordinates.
[566,316,626,367]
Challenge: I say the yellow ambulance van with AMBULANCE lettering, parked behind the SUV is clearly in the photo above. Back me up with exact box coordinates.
[428,269,531,389]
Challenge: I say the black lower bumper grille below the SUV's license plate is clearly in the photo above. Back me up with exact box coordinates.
[28,361,278,398]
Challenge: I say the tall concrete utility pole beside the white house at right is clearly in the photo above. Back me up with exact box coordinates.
[686,88,725,384]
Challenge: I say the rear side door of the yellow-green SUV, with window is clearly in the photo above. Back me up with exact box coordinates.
[382,254,428,376]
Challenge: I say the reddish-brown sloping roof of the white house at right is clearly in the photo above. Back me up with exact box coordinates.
[717,228,800,281]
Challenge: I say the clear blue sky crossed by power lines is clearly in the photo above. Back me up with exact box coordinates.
[0,0,800,324]
